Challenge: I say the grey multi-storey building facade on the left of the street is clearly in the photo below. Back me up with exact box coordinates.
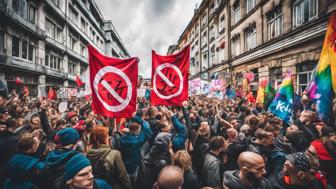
[0,0,129,96]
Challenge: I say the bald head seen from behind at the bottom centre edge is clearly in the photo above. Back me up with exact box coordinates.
[154,165,183,189]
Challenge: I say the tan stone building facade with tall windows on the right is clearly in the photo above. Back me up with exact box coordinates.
[168,0,336,93]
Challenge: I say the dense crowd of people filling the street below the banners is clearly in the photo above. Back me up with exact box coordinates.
[0,86,336,189]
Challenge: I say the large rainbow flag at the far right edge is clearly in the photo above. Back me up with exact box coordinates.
[306,12,336,123]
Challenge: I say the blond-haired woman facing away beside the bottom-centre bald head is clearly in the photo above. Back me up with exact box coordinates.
[172,150,200,189]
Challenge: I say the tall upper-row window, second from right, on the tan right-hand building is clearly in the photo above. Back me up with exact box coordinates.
[267,7,283,39]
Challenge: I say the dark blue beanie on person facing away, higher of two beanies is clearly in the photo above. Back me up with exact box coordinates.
[54,127,79,146]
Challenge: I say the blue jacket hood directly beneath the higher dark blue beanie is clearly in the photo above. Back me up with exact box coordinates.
[45,149,79,166]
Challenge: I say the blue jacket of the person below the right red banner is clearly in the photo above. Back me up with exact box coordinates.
[171,115,187,152]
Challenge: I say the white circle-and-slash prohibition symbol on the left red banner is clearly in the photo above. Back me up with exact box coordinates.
[93,66,132,112]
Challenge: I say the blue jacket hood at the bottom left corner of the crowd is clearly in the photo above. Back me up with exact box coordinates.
[7,154,46,180]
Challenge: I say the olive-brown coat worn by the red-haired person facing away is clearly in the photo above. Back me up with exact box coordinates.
[87,144,132,189]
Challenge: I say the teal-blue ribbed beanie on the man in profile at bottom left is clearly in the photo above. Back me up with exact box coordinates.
[64,153,91,181]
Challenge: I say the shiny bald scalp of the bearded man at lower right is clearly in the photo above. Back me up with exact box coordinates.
[238,152,265,169]
